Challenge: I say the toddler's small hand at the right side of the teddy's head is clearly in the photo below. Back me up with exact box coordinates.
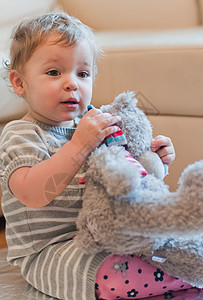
[151,135,175,166]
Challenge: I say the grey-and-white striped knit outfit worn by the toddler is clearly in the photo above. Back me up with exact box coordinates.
[0,119,107,300]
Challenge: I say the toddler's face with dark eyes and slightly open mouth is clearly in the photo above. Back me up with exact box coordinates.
[15,39,93,126]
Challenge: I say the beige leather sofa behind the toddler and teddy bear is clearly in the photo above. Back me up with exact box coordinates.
[0,0,203,216]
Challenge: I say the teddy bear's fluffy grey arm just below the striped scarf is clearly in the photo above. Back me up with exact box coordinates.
[87,145,141,197]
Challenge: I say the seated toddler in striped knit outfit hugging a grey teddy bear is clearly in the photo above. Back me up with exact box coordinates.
[0,13,189,300]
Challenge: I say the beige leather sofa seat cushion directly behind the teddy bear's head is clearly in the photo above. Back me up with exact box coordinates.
[93,27,203,116]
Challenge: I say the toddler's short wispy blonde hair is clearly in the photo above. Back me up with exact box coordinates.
[5,13,100,77]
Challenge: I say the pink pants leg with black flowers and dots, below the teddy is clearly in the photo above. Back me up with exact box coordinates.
[95,255,200,300]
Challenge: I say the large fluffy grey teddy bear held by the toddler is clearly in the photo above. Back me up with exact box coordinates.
[75,92,203,288]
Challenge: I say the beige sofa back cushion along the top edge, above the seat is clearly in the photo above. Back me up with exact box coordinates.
[59,0,199,30]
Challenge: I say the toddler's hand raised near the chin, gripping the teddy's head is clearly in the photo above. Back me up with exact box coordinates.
[71,108,121,154]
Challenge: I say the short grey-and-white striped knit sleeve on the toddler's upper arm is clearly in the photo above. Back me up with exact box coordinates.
[0,120,50,188]
